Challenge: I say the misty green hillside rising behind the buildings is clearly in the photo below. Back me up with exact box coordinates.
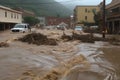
[0,0,72,17]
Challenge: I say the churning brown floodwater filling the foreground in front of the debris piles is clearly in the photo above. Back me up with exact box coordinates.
[0,30,120,80]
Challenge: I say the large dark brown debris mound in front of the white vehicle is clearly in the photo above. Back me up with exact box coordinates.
[18,33,57,45]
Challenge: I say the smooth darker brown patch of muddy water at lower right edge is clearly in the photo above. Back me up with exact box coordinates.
[101,46,120,80]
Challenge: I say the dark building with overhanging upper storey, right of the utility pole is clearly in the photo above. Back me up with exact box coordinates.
[106,0,120,34]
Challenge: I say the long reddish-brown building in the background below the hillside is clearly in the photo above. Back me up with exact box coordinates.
[46,17,71,27]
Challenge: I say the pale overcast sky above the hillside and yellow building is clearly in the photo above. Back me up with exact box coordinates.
[55,0,112,5]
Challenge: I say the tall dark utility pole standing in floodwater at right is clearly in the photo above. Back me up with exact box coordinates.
[102,0,106,38]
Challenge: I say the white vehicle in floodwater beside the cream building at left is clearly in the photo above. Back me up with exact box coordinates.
[11,23,31,33]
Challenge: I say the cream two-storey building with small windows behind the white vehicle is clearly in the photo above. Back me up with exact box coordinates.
[0,6,22,30]
